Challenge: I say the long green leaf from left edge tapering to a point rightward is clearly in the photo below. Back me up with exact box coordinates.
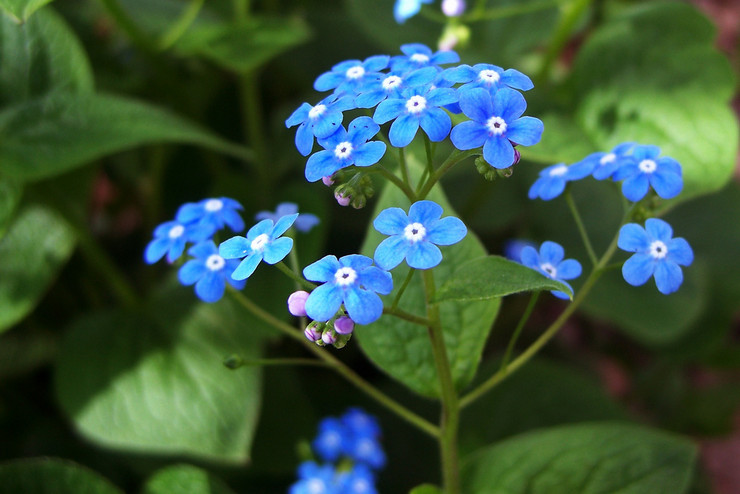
[0,94,248,180]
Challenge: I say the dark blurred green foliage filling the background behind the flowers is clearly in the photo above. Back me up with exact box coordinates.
[0,0,740,494]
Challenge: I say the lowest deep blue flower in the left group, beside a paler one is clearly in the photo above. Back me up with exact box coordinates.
[177,240,246,303]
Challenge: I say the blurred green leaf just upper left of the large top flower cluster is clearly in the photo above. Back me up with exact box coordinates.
[176,17,310,73]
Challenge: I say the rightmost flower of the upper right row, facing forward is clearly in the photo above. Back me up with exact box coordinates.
[612,145,683,202]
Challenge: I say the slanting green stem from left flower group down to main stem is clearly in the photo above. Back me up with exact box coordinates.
[229,286,440,438]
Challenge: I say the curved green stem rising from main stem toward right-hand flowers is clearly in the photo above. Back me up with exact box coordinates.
[460,222,630,408]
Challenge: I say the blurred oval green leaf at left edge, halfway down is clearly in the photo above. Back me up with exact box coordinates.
[0,206,75,333]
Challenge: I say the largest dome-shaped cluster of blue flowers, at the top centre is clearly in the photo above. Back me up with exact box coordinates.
[285,43,543,182]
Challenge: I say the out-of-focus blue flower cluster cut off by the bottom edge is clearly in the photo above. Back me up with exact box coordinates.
[288,408,386,494]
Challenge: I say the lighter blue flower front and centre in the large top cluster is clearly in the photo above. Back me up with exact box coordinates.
[373,85,457,148]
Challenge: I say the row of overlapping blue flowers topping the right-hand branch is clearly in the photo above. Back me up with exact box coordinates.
[529,142,683,202]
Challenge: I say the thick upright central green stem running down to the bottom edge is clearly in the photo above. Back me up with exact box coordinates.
[422,269,460,494]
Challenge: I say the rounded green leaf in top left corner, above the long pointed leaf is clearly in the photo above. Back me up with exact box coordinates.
[0,8,93,106]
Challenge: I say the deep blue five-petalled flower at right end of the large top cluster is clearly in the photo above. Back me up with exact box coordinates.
[450,88,544,172]
